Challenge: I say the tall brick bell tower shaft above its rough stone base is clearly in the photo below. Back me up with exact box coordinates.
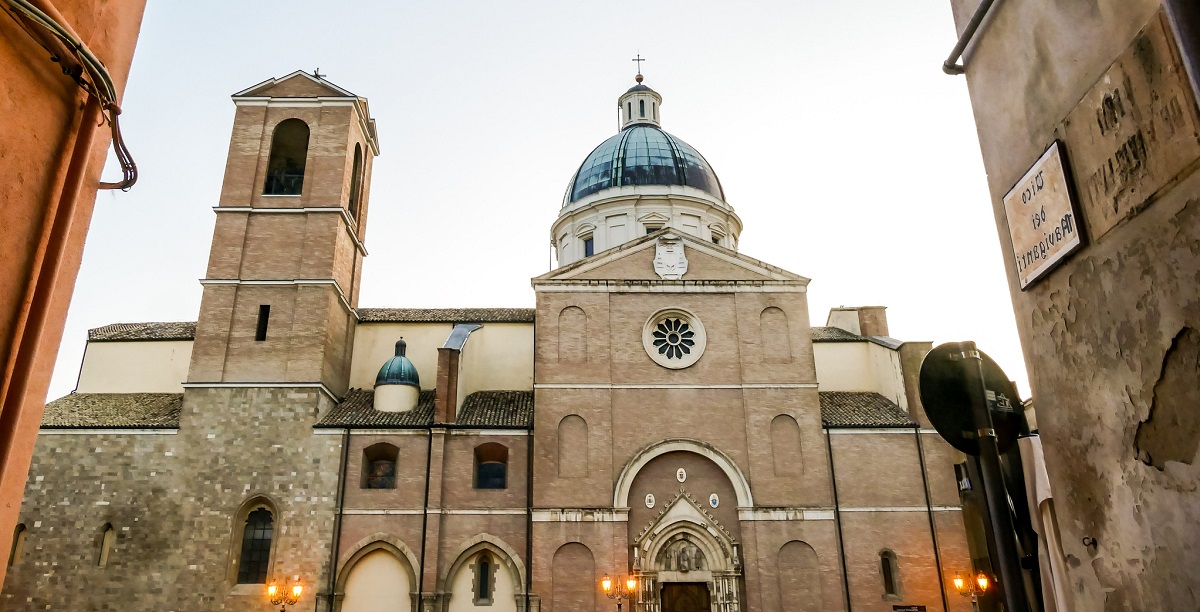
[188,71,379,396]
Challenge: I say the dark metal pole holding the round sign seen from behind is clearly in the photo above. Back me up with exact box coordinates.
[959,341,1028,612]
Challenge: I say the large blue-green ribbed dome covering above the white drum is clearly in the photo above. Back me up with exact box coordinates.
[563,124,725,206]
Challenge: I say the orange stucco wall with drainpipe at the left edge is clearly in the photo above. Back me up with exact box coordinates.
[0,0,145,578]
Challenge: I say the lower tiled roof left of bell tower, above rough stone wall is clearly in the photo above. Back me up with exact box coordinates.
[42,394,184,430]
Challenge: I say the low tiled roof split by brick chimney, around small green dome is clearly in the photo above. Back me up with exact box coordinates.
[317,389,533,430]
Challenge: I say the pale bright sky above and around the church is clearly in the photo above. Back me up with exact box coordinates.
[49,0,1028,398]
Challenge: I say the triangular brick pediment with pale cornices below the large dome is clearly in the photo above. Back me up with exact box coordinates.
[533,228,809,287]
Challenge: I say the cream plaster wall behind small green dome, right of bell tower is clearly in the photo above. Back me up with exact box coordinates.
[350,323,456,389]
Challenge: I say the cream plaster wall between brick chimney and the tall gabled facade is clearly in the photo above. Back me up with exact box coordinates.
[458,323,533,393]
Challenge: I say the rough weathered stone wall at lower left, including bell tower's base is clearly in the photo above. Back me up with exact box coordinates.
[0,389,341,612]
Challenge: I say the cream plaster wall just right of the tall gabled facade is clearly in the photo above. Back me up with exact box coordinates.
[812,342,908,410]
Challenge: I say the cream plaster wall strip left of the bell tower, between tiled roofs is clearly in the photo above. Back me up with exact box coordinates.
[76,340,192,394]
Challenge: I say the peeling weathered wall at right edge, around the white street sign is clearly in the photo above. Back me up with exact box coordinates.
[952,0,1200,611]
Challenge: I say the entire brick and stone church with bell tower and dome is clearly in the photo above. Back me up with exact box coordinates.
[0,72,971,612]
